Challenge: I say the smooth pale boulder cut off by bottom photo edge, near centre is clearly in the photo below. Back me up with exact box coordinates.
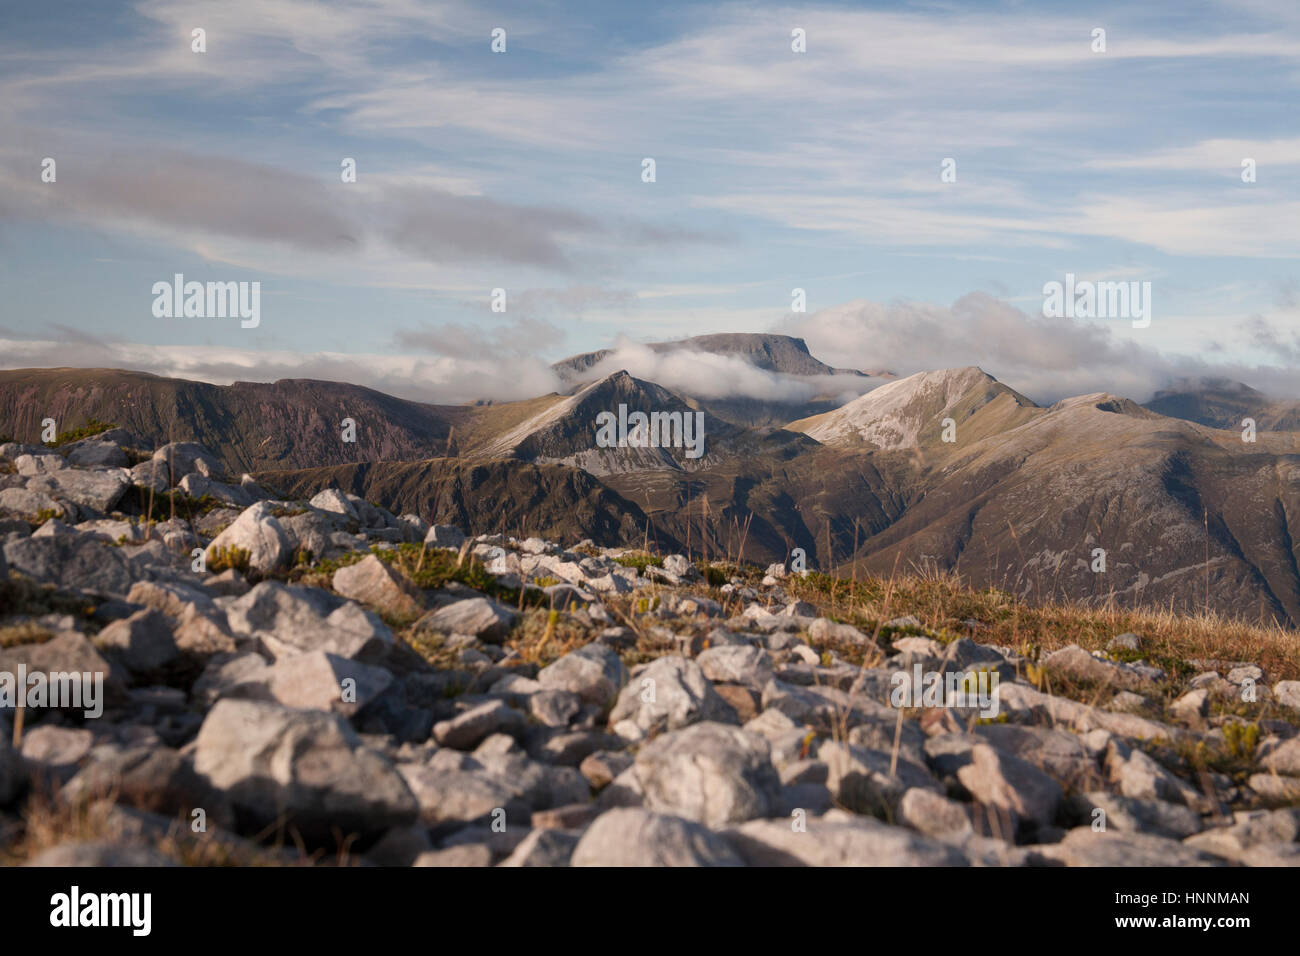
[569,808,744,866]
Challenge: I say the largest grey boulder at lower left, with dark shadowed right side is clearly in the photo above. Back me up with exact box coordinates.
[194,700,419,845]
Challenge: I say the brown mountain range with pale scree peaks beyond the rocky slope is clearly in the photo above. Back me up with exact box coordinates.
[0,334,1300,626]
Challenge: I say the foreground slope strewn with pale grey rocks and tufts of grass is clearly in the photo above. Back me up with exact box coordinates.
[0,432,1300,866]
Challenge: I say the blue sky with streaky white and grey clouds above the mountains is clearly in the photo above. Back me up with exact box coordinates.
[0,0,1300,402]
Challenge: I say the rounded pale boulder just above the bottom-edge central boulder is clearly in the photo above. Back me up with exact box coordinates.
[636,722,781,826]
